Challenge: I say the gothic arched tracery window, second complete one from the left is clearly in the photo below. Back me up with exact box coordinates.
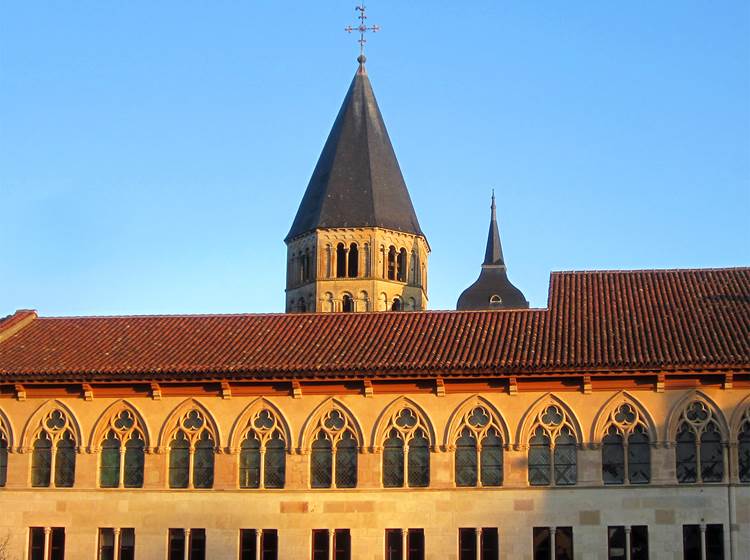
[99,410,145,488]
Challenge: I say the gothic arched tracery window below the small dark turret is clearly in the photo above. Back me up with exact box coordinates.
[455,406,503,486]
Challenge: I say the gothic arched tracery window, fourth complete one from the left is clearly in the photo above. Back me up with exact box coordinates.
[240,408,286,488]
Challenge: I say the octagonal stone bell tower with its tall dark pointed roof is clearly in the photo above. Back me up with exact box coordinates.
[285,54,430,313]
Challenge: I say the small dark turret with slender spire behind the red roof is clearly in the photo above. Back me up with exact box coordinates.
[456,191,529,311]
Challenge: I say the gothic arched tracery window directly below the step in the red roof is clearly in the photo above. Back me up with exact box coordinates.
[529,405,578,486]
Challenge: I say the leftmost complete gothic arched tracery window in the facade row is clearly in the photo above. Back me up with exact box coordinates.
[31,409,76,488]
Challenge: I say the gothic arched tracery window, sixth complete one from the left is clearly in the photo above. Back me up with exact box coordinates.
[383,408,430,488]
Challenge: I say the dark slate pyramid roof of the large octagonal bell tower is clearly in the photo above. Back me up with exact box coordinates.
[286,62,424,241]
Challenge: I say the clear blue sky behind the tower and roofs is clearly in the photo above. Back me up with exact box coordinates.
[0,0,750,316]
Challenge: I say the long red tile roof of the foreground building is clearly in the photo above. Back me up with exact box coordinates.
[0,268,750,381]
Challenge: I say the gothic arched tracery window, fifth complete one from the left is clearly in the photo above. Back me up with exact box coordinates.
[310,409,358,488]
